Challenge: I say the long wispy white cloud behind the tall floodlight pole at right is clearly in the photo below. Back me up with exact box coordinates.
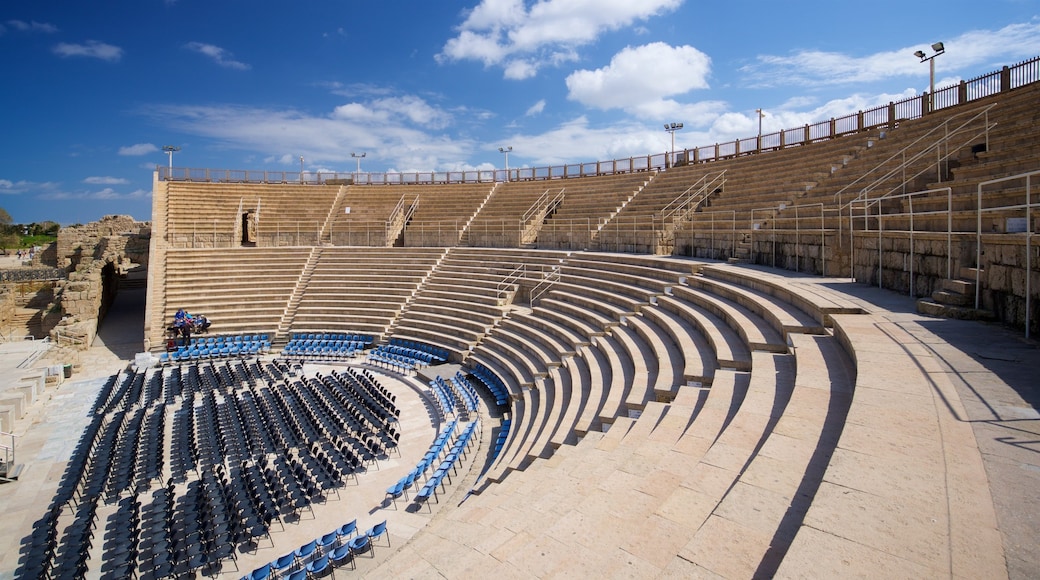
[740,19,1040,86]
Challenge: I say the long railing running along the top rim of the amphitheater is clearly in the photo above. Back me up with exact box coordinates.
[156,56,1040,190]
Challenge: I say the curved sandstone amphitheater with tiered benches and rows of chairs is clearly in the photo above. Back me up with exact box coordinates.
[0,59,1040,578]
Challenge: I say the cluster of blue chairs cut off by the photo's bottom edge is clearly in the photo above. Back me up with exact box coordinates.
[242,520,390,580]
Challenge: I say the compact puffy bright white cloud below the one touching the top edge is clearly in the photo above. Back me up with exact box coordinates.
[567,43,711,118]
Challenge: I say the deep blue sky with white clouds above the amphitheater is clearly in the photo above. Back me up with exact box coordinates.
[0,0,1040,225]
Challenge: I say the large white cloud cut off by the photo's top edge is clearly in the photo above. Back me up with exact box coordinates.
[437,0,682,79]
